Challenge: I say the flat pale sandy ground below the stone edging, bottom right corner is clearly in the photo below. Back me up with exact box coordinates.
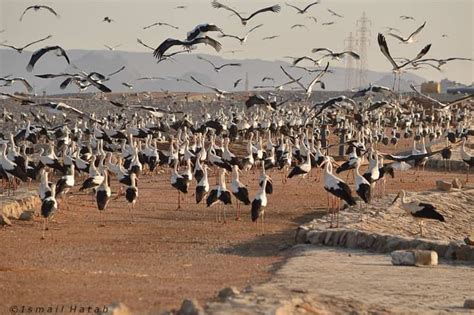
[257,245,474,314]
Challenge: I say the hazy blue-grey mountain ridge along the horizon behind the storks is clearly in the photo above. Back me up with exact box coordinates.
[0,49,426,94]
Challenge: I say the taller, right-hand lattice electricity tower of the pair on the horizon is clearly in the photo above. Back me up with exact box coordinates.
[356,12,372,88]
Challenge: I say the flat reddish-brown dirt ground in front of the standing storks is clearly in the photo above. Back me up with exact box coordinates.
[0,159,470,314]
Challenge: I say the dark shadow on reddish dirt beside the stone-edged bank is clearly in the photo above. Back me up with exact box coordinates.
[218,209,325,257]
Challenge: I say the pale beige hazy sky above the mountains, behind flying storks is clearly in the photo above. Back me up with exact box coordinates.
[0,0,474,84]
